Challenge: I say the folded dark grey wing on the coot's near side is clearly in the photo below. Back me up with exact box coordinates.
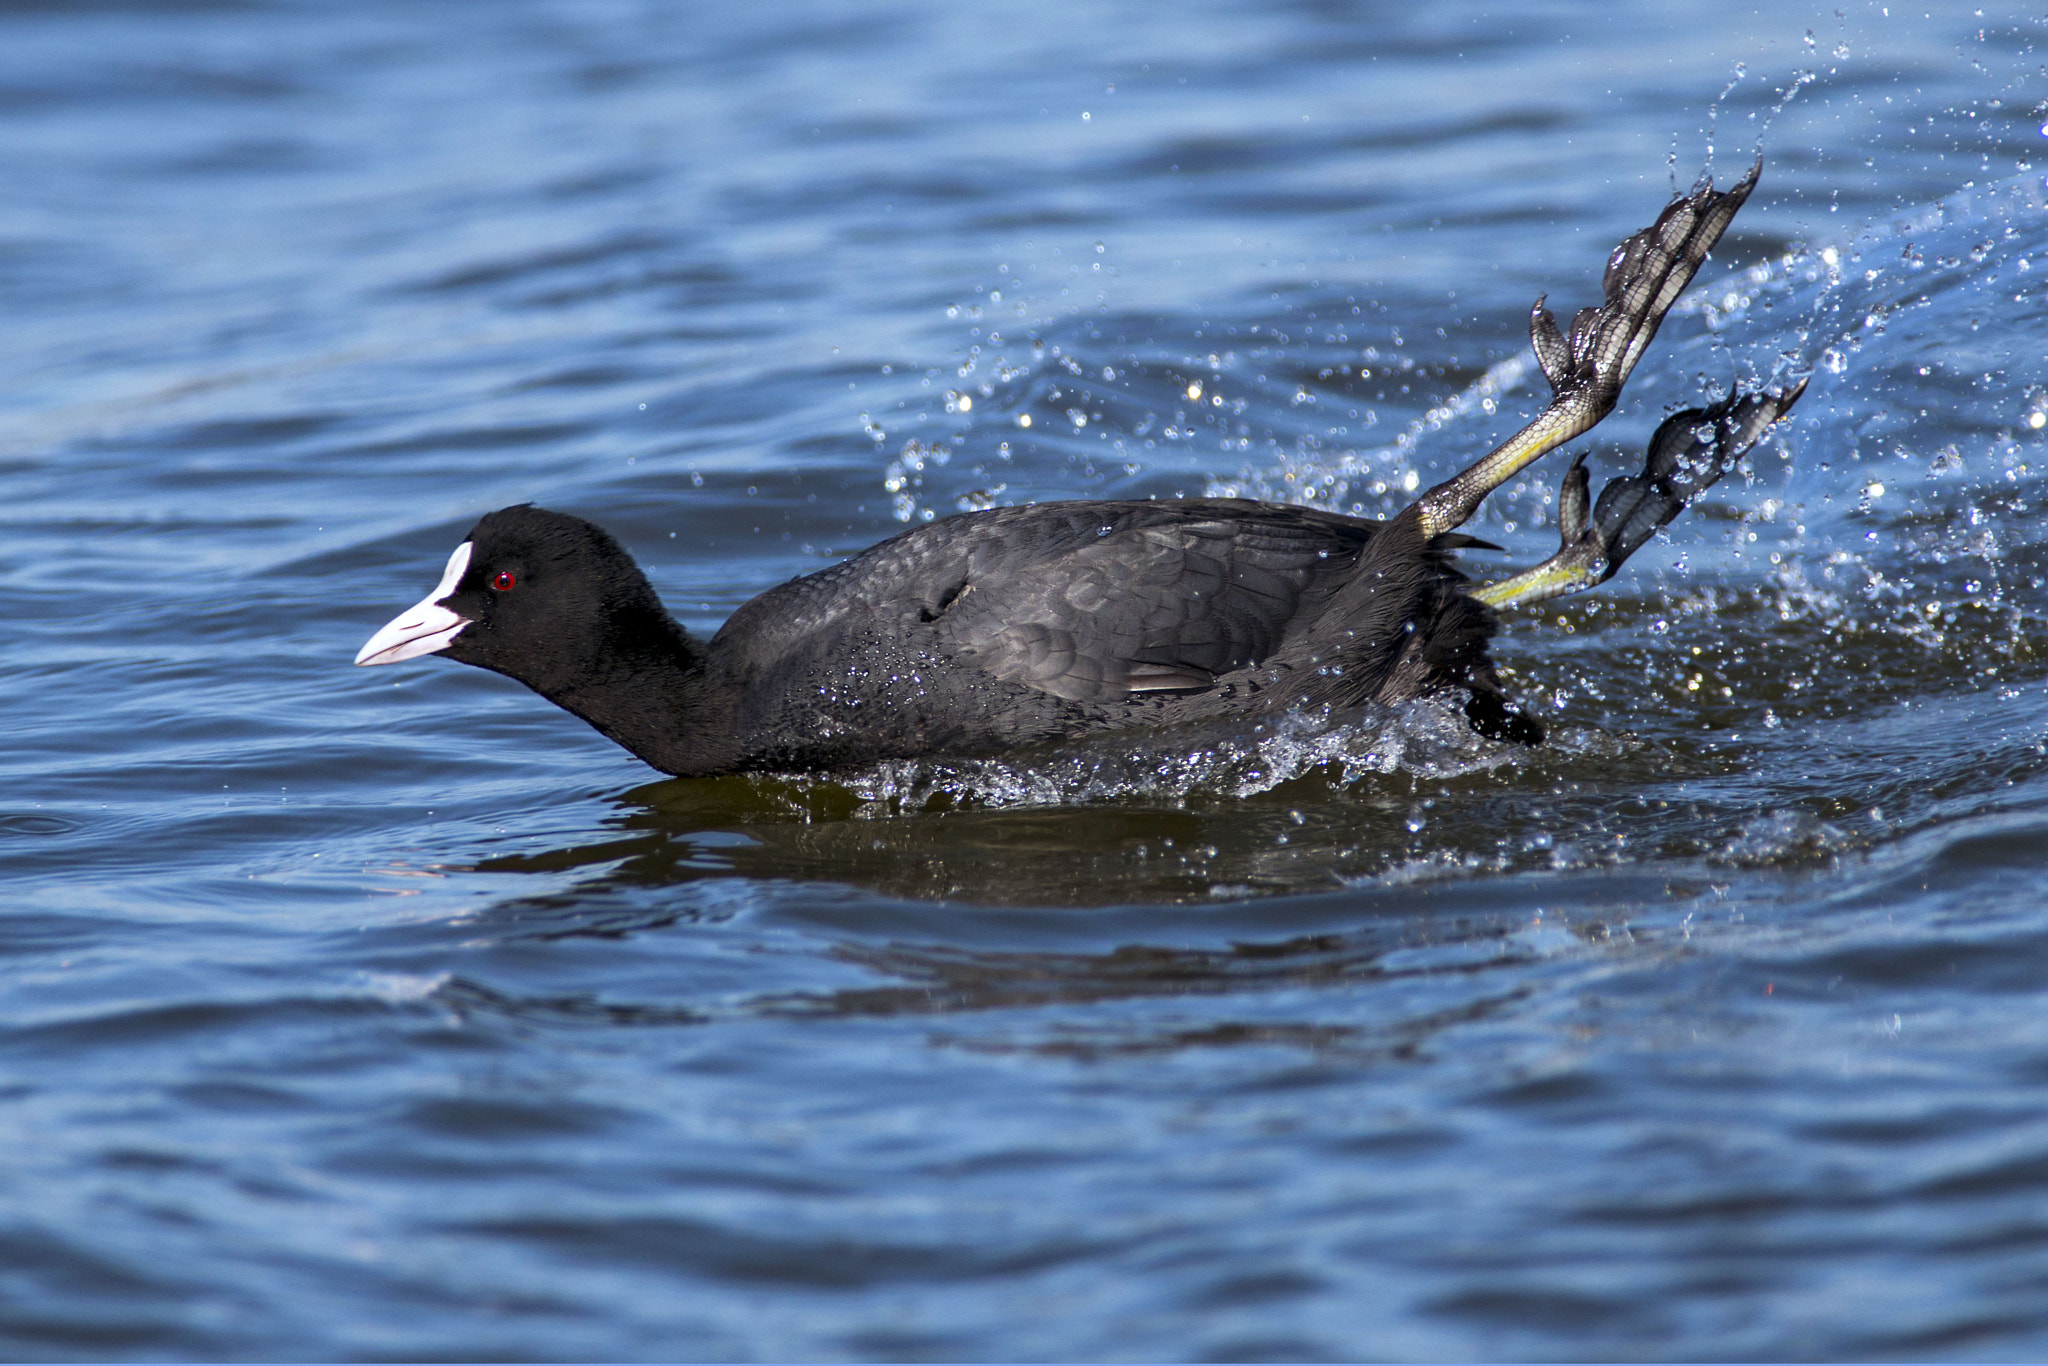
[715,500,1384,702]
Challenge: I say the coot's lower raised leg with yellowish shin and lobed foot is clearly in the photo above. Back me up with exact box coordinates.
[1473,379,1806,608]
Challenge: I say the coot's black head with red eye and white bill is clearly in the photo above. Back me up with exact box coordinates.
[356,504,680,696]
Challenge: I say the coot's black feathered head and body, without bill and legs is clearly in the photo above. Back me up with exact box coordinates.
[387,500,1538,774]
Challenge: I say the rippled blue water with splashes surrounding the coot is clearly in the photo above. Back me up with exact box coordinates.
[0,0,2048,1358]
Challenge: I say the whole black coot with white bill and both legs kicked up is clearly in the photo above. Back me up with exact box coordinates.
[356,162,1804,776]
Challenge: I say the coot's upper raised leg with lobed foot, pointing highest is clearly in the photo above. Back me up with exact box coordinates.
[1415,160,1763,537]
